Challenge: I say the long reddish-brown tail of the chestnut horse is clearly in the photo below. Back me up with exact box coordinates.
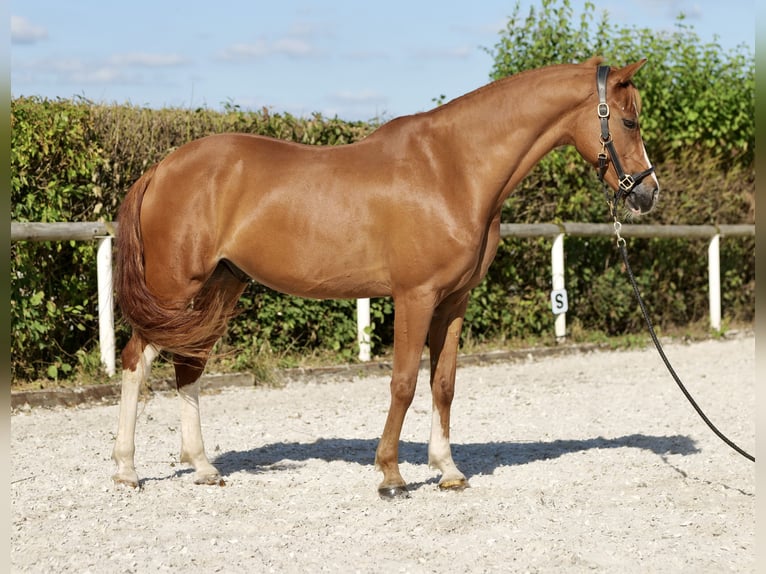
[115,165,230,357]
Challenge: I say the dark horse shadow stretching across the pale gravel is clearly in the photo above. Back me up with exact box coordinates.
[213,434,699,484]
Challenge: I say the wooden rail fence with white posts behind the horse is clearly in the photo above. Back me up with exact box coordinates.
[11,221,755,376]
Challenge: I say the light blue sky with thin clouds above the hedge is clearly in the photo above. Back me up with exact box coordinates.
[10,0,755,120]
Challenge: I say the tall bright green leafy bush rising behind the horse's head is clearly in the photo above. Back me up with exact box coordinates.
[487,0,755,170]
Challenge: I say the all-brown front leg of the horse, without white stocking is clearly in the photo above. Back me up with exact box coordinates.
[375,296,433,499]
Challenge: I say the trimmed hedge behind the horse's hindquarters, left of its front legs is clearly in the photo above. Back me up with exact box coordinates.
[11,102,380,381]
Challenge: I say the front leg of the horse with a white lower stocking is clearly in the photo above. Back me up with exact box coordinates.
[428,296,468,490]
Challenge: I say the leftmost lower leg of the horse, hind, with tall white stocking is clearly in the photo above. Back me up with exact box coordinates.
[112,335,158,488]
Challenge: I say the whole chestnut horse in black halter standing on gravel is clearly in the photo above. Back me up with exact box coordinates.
[112,58,659,498]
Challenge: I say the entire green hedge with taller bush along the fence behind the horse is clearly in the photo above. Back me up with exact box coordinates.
[11,1,755,384]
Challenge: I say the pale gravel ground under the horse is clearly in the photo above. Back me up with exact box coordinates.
[11,335,755,573]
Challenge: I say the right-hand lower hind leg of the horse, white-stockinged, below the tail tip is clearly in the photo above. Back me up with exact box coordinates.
[174,356,224,485]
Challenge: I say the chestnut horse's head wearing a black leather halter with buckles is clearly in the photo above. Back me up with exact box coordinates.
[575,58,660,215]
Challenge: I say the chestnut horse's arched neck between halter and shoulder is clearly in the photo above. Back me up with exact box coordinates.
[435,66,596,207]
